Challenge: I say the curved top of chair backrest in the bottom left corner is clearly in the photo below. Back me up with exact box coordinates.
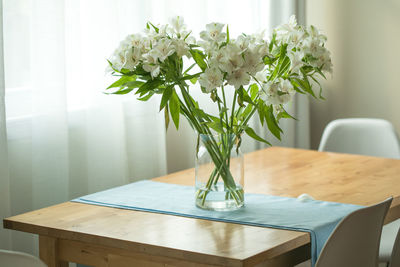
[0,249,47,267]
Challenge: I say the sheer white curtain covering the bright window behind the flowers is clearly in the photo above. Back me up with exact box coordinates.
[0,0,308,253]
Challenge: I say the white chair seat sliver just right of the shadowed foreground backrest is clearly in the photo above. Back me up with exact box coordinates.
[379,219,400,262]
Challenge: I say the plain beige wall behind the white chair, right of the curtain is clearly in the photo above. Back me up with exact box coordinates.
[306,0,400,148]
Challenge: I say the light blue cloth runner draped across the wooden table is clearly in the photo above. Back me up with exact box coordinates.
[72,181,362,265]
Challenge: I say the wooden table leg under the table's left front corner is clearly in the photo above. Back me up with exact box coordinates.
[39,235,68,267]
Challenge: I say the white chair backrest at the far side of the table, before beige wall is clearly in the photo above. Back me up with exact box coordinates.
[318,118,400,159]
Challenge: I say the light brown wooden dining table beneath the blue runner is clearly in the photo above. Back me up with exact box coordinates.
[4,147,400,267]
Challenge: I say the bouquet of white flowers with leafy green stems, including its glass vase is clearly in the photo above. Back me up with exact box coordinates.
[107,16,332,210]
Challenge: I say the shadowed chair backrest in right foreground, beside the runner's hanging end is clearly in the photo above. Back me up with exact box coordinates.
[316,198,392,267]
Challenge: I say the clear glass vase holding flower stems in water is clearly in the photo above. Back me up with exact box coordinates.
[195,134,244,211]
